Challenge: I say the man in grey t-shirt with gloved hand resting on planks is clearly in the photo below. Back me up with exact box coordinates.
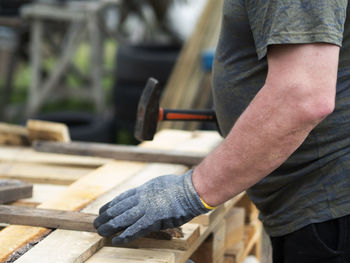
[95,0,350,263]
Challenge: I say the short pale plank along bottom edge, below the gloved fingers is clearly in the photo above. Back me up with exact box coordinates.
[85,247,175,263]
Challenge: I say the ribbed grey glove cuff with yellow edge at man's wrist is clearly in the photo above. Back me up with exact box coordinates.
[183,169,212,216]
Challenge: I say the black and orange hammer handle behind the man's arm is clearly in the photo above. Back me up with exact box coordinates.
[158,108,216,122]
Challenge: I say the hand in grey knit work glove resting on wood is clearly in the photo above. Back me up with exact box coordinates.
[94,170,210,245]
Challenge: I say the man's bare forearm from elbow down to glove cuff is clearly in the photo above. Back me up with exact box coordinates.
[193,82,321,206]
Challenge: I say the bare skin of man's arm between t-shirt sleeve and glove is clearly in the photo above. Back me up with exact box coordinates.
[192,43,339,206]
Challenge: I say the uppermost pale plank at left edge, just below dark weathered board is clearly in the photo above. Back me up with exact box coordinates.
[0,146,113,168]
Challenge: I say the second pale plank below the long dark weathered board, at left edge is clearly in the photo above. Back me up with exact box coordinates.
[0,162,93,185]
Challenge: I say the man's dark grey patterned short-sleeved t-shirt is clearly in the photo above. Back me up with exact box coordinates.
[213,0,350,236]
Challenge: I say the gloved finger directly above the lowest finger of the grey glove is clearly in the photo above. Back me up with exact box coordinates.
[97,207,143,236]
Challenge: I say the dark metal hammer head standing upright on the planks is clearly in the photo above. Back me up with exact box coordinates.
[134,78,161,141]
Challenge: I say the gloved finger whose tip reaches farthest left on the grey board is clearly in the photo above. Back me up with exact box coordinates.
[94,195,138,229]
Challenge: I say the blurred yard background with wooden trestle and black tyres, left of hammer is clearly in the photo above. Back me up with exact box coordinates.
[0,0,207,144]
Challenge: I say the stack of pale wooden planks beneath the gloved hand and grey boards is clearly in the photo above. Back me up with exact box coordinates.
[0,124,261,263]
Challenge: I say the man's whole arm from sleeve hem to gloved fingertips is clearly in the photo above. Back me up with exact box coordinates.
[94,41,339,244]
